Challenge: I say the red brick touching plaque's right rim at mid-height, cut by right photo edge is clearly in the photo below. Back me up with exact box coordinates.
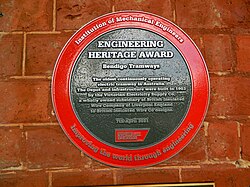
[207,76,250,116]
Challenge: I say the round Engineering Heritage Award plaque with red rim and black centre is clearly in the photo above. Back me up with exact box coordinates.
[52,11,209,167]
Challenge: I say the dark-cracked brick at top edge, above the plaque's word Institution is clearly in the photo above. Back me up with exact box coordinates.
[57,0,112,30]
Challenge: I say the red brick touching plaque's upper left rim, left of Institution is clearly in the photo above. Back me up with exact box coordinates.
[26,33,73,75]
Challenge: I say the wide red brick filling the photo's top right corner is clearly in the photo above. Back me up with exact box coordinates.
[176,0,250,29]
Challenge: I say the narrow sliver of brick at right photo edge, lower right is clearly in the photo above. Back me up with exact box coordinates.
[241,122,250,161]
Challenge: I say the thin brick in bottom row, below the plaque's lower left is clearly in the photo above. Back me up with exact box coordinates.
[52,170,114,186]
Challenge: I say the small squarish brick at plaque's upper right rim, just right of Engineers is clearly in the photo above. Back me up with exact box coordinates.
[203,34,234,72]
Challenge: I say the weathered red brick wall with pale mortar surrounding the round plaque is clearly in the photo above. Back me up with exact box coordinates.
[0,0,250,187]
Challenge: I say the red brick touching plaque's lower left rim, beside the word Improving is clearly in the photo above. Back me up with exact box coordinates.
[25,126,91,169]
